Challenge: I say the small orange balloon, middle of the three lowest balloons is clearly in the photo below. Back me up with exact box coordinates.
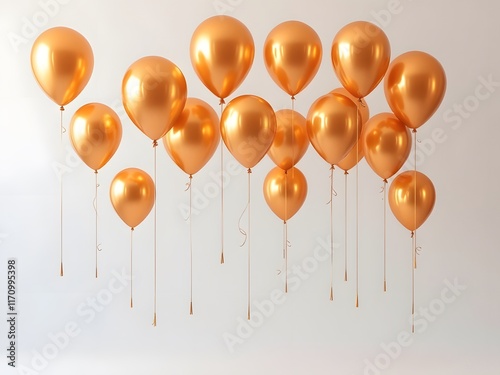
[264,167,307,221]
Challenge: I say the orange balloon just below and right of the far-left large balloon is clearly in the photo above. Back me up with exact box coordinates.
[69,103,122,171]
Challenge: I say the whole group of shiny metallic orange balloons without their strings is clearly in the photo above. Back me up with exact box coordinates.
[31,16,446,235]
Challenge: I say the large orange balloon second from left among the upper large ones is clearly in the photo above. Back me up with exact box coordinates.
[122,56,187,141]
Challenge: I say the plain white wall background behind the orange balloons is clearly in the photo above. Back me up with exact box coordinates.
[0,0,500,375]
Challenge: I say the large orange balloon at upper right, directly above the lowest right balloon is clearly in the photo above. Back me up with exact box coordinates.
[384,51,446,129]
